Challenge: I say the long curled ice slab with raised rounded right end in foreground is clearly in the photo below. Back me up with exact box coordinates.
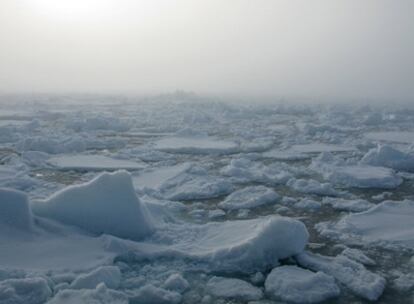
[108,216,309,274]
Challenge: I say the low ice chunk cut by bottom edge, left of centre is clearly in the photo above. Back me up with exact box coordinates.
[130,284,182,304]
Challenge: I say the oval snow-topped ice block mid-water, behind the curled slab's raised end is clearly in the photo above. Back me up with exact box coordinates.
[218,186,280,210]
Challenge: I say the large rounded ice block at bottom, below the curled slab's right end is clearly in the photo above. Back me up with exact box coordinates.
[265,266,340,303]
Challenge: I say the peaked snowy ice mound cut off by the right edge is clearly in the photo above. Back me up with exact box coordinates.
[361,145,414,171]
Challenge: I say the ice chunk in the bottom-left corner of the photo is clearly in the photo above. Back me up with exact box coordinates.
[0,277,52,304]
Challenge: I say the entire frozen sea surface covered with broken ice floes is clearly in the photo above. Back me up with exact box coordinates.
[0,95,414,304]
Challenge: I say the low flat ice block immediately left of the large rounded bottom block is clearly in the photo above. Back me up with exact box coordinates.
[206,277,263,301]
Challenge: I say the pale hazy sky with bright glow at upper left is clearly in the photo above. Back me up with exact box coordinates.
[0,0,414,99]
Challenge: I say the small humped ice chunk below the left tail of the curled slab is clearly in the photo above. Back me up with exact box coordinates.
[70,266,121,289]
